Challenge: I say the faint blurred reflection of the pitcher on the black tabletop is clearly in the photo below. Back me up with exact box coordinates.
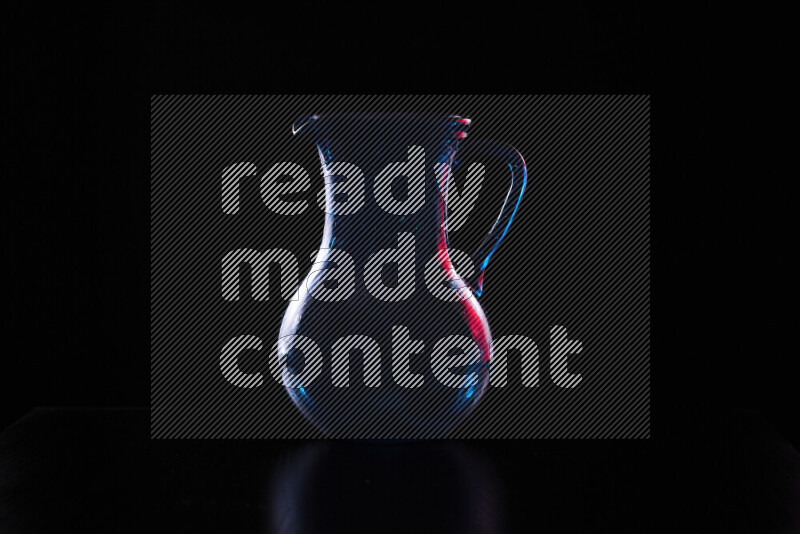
[269,441,504,533]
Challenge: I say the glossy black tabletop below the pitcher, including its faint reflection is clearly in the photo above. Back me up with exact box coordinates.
[0,410,800,534]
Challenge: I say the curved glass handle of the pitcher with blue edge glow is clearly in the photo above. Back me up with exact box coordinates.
[462,140,528,297]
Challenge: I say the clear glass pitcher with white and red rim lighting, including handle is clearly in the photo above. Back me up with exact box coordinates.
[270,114,526,439]
